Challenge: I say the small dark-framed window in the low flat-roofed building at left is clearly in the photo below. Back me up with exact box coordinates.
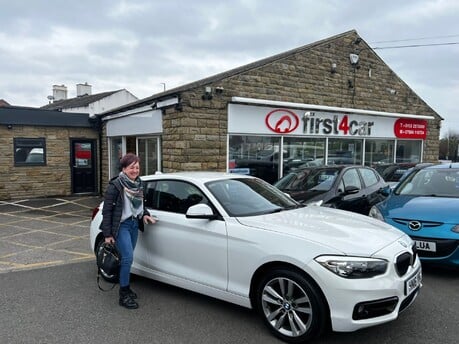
[14,138,46,166]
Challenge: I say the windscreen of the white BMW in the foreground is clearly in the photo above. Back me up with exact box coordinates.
[206,178,302,216]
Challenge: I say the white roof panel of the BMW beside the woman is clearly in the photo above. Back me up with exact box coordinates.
[140,171,255,183]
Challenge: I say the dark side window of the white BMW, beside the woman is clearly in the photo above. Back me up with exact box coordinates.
[145,180,208,214]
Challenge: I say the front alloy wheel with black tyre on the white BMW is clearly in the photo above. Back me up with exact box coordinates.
[256,270,328,343]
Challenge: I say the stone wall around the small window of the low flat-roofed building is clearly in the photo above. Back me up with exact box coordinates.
[0,125,98,200]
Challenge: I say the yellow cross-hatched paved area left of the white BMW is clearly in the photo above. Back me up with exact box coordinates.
[0,196,102,273]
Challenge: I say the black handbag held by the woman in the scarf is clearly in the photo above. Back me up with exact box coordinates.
[96,242,121,291]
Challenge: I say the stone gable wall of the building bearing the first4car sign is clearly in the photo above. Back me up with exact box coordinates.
[158,33,440,172]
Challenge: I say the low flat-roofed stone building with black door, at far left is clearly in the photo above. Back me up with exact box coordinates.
[0,106,100,200]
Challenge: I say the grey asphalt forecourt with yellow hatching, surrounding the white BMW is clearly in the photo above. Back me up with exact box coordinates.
[0,197,459,344]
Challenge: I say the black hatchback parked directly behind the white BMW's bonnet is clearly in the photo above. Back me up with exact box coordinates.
[274,165,387,215]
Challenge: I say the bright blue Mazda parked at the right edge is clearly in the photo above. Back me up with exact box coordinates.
[369,163,459,267]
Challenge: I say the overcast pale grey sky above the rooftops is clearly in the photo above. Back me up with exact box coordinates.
[0,0,459,135]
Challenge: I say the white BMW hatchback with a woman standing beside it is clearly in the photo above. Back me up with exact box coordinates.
[90,172,422,343]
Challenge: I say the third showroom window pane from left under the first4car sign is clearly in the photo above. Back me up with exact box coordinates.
[327,139,362,165]
